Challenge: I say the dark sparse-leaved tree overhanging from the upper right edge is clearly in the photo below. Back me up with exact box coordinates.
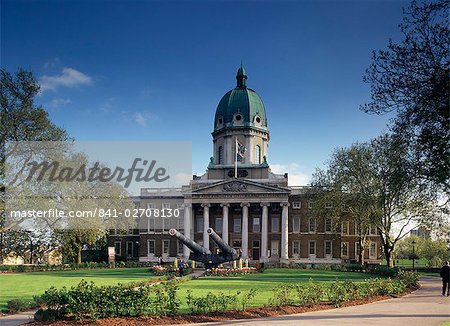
[361,0,450,194]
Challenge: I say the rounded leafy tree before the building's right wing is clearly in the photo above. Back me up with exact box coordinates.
[316,135,436,266]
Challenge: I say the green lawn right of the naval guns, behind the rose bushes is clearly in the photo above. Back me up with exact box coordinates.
[179,268,379,312]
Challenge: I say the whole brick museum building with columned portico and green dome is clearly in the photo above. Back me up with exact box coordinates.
[109,65,381,264]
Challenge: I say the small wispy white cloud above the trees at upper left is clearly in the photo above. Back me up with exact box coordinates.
[39,67,92,92]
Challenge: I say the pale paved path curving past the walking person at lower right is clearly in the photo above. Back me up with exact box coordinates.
[191,277,450,326]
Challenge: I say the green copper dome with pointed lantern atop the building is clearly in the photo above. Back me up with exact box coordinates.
[214,65,267,131]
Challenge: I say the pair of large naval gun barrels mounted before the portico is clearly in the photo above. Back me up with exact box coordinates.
[169,228,240,269]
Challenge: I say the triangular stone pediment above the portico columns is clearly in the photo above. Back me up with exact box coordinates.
[192,179,290,194]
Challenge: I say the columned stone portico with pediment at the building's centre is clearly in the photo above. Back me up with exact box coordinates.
[183,179,289,262]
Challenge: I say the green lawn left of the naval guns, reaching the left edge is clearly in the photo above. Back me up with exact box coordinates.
[0,267,155,310]
